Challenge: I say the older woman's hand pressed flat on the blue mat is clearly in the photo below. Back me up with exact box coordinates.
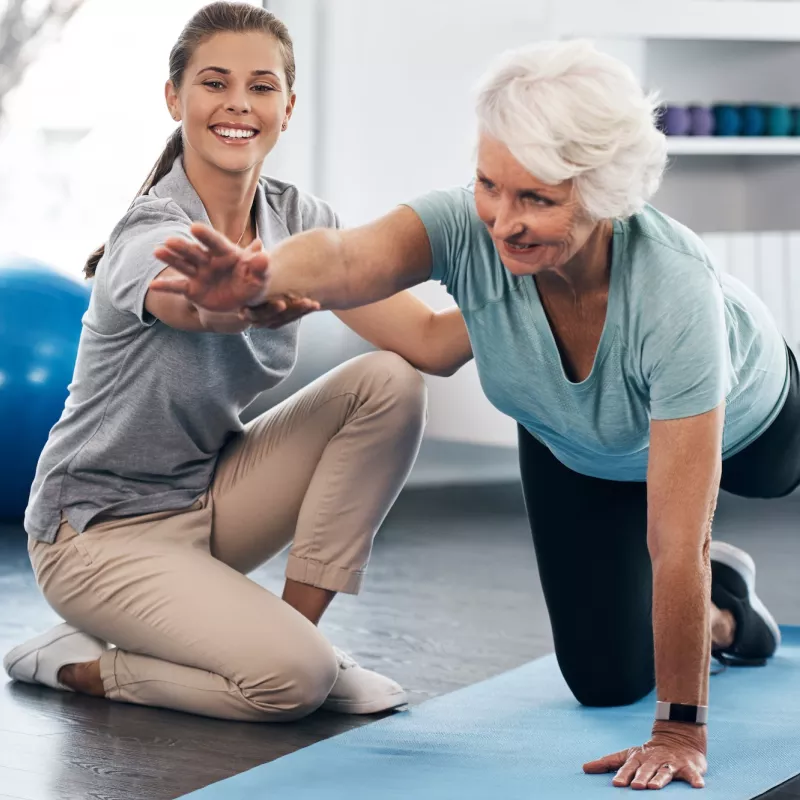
[583,722,708,789]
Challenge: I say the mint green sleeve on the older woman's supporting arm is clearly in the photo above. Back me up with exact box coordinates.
[642,256,731,419]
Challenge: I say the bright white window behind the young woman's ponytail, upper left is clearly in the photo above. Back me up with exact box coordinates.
[0,0,247,276]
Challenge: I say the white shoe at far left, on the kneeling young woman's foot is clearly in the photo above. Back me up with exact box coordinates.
[3,622,108,692]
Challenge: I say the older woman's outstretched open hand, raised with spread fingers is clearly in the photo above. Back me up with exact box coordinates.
[150,222,269,313]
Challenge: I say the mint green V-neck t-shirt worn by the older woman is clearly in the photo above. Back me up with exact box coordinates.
[409,188,788,481]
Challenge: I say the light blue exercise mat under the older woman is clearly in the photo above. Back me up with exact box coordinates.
[187,627,800,800]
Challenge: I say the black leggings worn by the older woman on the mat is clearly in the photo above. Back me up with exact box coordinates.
[518,344,800,706]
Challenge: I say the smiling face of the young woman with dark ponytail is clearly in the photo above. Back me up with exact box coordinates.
[166,32,295,172]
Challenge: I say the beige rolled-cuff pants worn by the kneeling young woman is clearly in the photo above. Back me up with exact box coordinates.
[29,353,426,721]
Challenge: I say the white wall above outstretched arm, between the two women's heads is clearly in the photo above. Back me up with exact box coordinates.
[322,0,548,223]
